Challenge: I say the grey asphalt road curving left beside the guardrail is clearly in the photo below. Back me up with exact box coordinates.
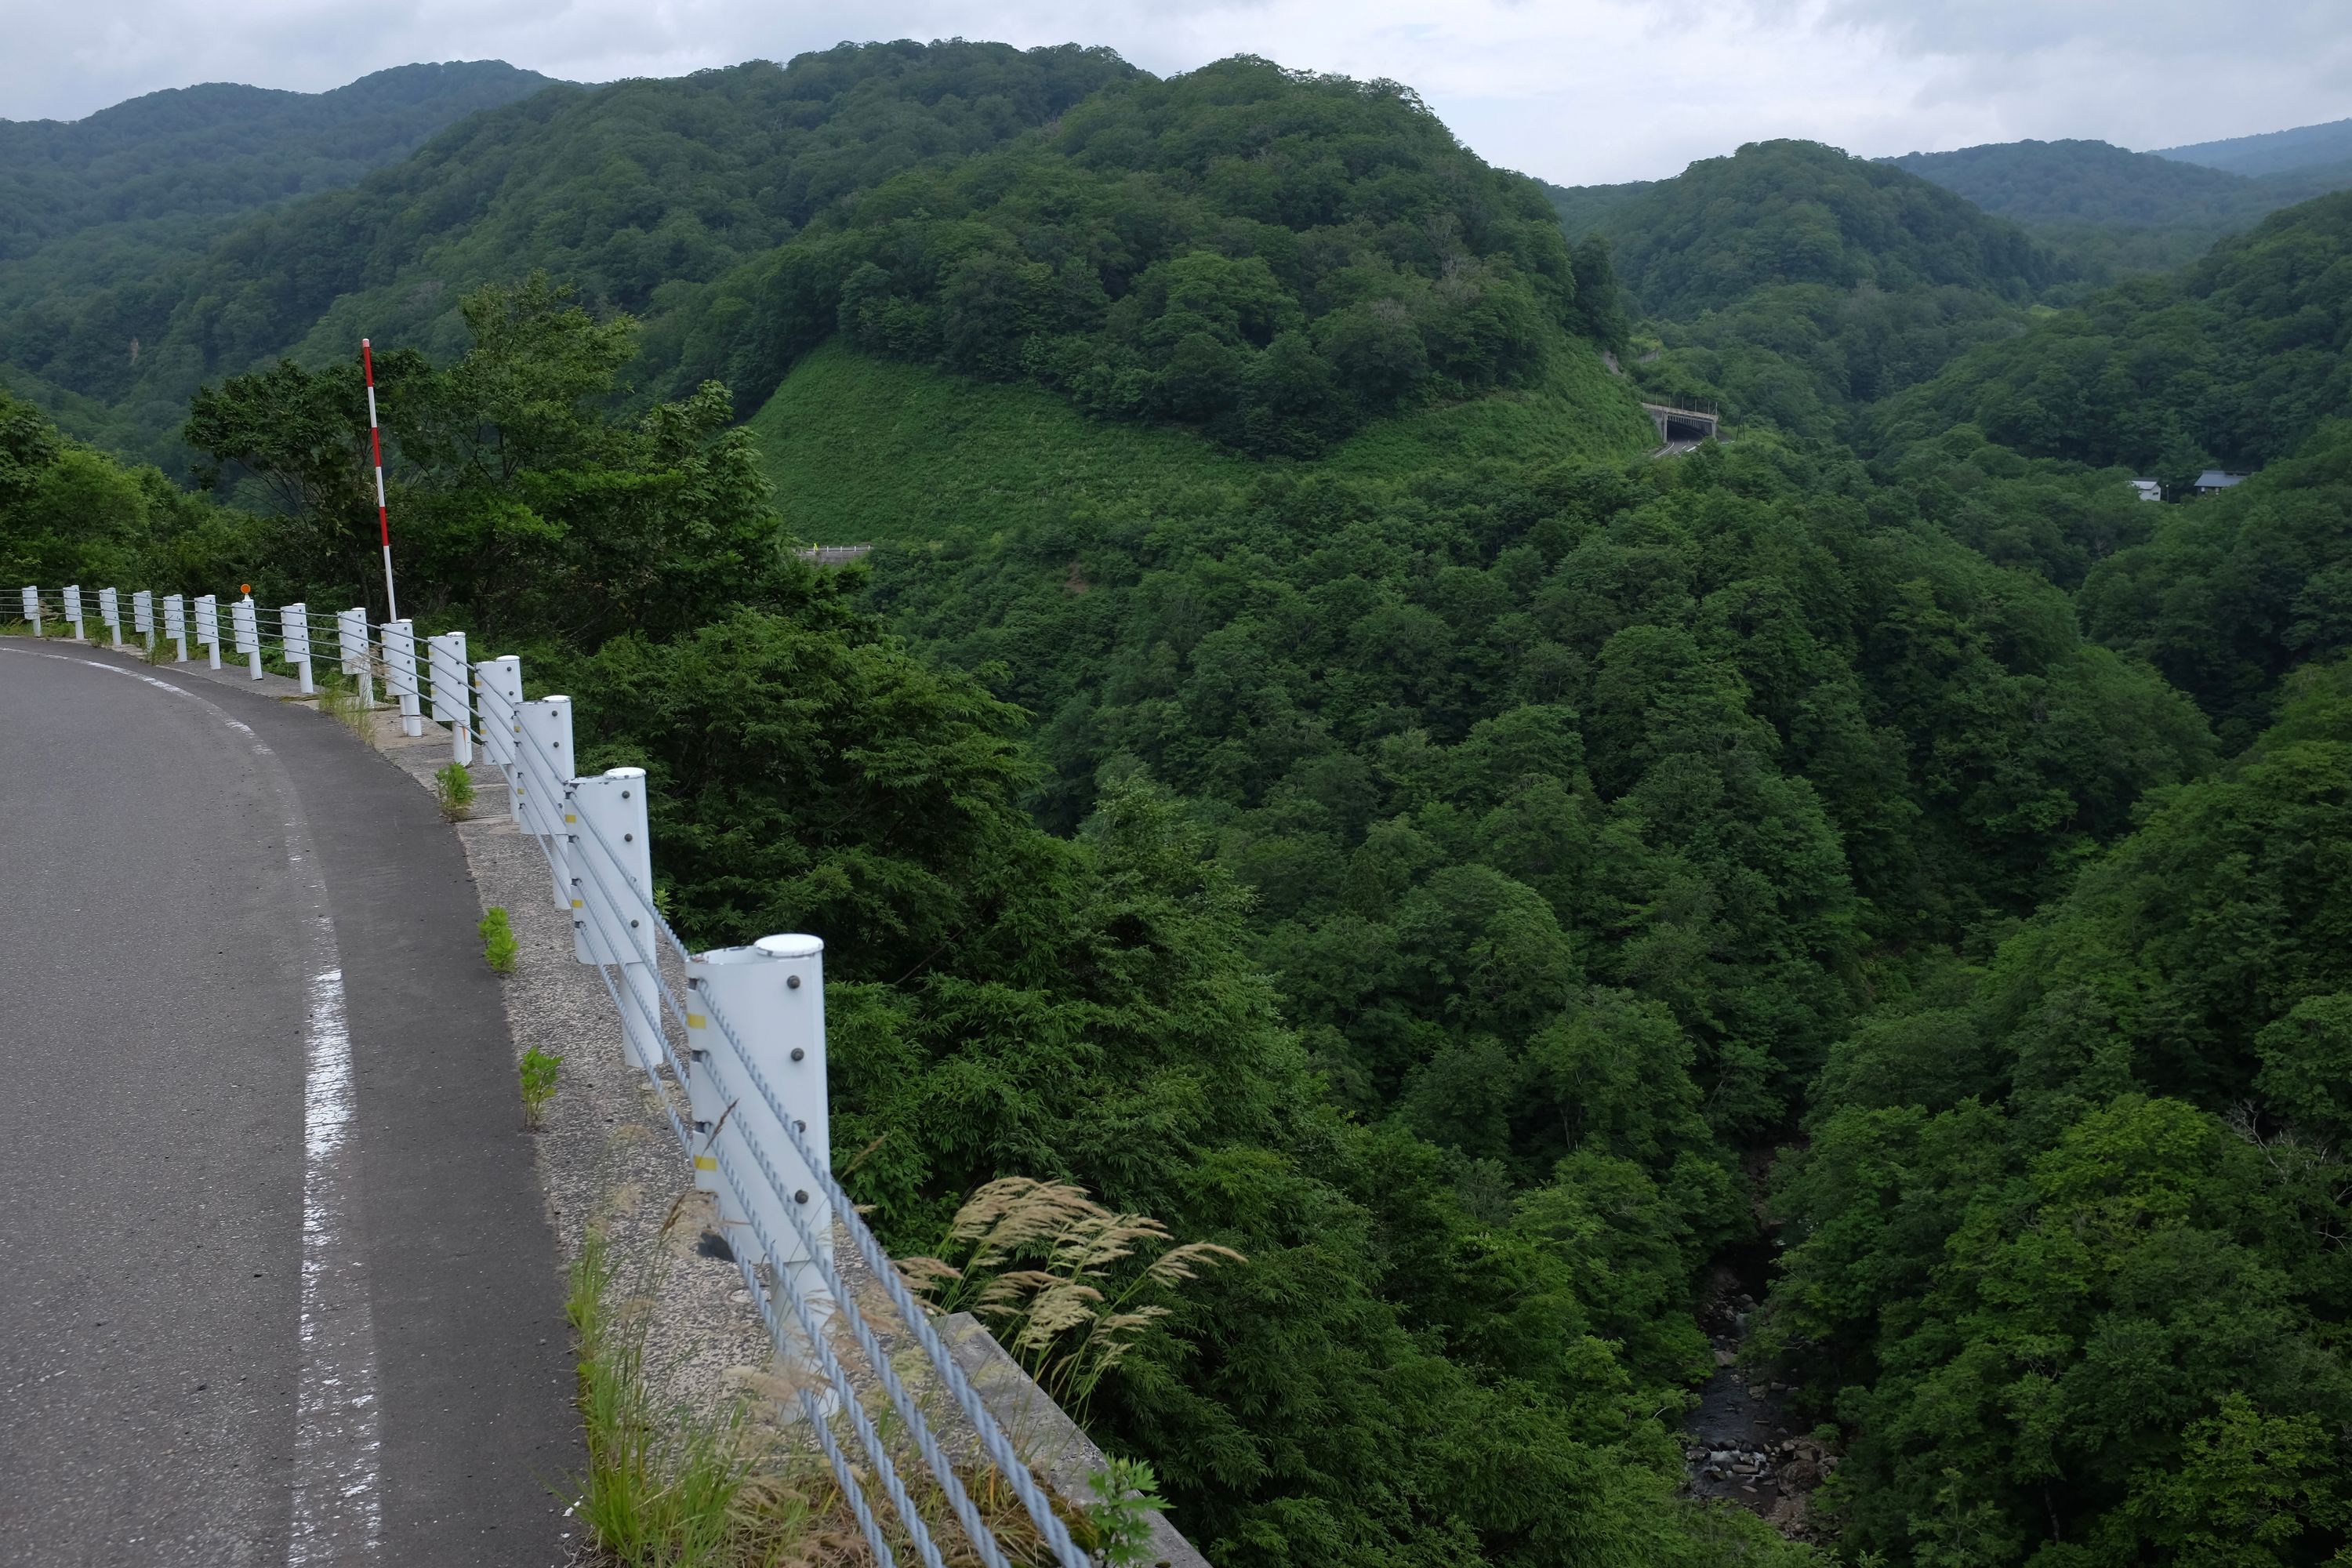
[0,640,581,1568]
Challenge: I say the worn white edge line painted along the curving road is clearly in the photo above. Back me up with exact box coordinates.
[0,649,383,1568]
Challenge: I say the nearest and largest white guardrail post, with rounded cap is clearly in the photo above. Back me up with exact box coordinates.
[687,935,833,1363]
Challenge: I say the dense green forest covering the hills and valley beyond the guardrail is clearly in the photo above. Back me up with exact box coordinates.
[0,45,2352,1568]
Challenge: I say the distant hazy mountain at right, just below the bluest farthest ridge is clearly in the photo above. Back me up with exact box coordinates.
[1886,141,2352,273]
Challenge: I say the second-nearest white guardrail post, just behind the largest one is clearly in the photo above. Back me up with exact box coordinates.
[567,769,661,1072]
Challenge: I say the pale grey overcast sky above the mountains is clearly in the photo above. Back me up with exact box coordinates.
[0,0,2352,186]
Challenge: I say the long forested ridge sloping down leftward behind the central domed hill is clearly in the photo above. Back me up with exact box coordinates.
[0,42,1131,463]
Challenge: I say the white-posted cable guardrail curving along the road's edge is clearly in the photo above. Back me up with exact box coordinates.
[24,586,1089,1568]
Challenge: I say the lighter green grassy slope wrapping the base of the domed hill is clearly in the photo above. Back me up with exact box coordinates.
[748,341,1656,543]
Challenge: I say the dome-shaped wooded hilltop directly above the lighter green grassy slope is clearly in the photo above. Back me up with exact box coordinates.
[656,59,1613,456]
